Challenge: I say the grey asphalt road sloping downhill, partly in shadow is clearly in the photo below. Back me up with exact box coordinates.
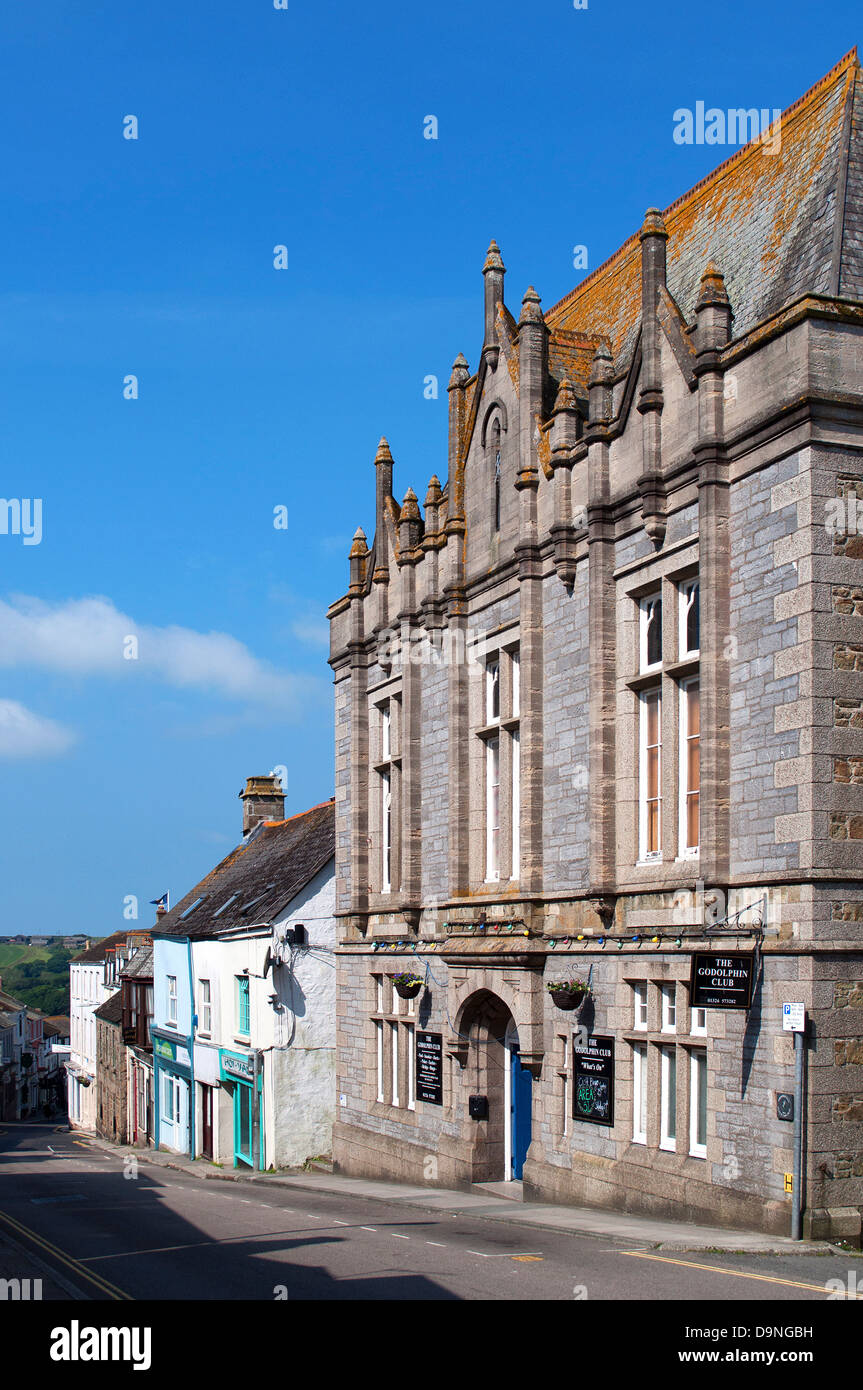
[0,1123,863,1304]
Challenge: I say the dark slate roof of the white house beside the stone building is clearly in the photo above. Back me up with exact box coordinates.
[154,801,335,937]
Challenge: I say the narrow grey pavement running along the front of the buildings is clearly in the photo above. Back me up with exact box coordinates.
[74,1130,846,1255]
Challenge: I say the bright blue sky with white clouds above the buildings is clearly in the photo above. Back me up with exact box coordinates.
[0,0,859,935]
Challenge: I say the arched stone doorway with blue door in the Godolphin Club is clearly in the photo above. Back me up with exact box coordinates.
[459,990,532,1183]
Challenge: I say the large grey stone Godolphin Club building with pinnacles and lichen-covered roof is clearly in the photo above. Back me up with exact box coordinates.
[329,50,863,1237]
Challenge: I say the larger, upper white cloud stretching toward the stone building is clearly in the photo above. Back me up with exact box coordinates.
[0,595,322,716]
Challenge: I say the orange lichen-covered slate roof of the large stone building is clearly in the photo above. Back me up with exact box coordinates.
[545,49,863,389]
